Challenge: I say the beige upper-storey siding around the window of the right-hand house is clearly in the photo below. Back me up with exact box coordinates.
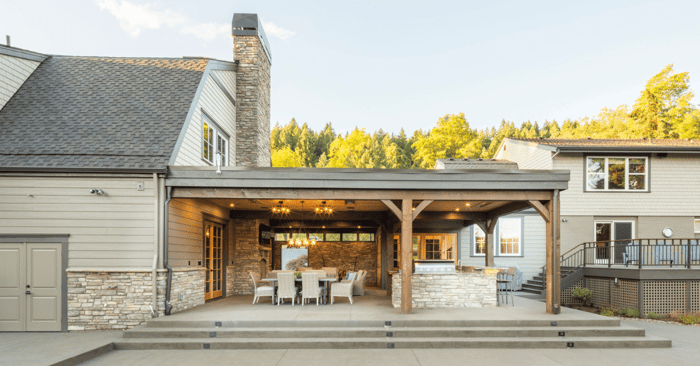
[554,153,700,216]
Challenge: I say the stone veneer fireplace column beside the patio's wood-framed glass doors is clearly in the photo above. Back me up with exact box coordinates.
[231,220,272,296]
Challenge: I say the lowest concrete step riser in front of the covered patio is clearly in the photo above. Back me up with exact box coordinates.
[115,339,671,350]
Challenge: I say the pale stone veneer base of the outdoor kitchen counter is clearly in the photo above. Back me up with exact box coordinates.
[391,272,498,308]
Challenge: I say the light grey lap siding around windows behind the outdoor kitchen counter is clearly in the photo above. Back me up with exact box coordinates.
[460,215,546,281]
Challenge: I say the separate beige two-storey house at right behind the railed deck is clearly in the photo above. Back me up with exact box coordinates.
[496,138,700,257]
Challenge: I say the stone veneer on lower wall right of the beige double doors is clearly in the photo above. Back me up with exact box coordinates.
[67,268,204,331]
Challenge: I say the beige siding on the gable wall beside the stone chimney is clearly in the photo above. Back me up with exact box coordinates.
[174,71,236,166]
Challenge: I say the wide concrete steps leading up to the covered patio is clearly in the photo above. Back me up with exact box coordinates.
[114,317,671,350]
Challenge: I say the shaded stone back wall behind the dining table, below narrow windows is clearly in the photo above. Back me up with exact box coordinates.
[274,241,379,285]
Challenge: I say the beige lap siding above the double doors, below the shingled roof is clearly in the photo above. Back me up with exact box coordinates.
[0,177,155,268]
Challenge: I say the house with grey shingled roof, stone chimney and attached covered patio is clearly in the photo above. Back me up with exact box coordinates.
[0,14,569,331]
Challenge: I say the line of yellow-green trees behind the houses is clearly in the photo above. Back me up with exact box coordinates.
[271,65,700,169]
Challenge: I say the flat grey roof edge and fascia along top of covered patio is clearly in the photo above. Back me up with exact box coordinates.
[166,166,569,191]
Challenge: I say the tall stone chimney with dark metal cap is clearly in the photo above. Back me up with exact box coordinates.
[232,13,272,166]
